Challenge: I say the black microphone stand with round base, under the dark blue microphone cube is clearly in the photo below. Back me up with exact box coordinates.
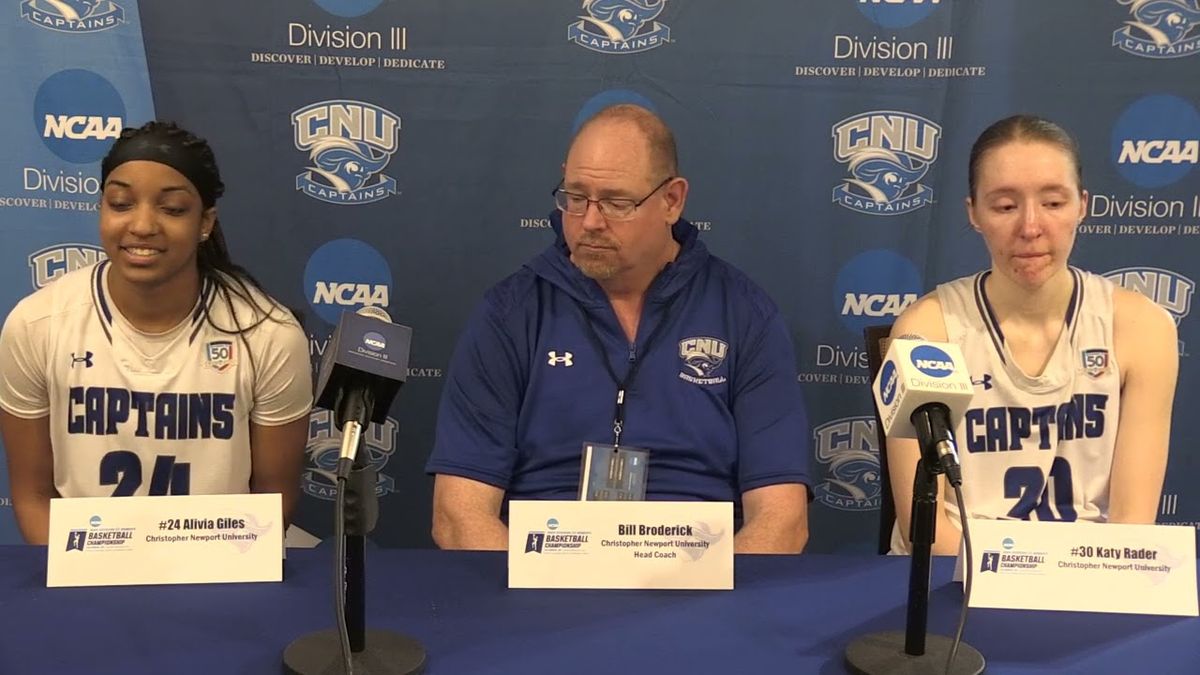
[283,420,426,675]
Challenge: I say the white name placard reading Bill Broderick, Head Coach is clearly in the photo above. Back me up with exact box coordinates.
[509,501,733,590]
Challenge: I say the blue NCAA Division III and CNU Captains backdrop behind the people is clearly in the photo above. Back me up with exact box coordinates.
[0,0,1200,551]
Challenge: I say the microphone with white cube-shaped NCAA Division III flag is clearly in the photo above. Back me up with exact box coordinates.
[871,339,974,486]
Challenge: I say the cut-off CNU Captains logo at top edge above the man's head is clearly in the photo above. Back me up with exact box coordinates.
[566,0,671,54]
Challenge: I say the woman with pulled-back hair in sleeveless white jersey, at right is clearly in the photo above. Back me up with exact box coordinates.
[888,115,1178,555]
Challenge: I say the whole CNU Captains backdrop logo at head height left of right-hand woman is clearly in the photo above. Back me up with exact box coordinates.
[833,110,942,215]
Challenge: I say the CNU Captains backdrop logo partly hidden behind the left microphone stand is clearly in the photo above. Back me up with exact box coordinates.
[300,410,400,501]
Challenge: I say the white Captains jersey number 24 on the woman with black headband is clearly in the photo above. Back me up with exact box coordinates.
[0,261,312,497]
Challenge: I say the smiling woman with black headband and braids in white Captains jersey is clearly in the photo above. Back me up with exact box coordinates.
[0,123,312,543]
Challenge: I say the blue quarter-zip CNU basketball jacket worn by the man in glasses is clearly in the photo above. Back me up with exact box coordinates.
[426,211,811,510]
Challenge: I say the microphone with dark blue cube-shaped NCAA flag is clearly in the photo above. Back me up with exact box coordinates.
[316,306,413,477]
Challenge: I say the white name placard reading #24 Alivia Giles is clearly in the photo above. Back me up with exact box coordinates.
[46,494,283,586]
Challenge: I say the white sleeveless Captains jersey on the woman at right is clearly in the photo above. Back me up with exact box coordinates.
[892,268,1121,552]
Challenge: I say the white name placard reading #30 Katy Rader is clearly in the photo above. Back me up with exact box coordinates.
[960,519,1198,616]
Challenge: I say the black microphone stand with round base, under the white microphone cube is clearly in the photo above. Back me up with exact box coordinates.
[846,406,984,675]
